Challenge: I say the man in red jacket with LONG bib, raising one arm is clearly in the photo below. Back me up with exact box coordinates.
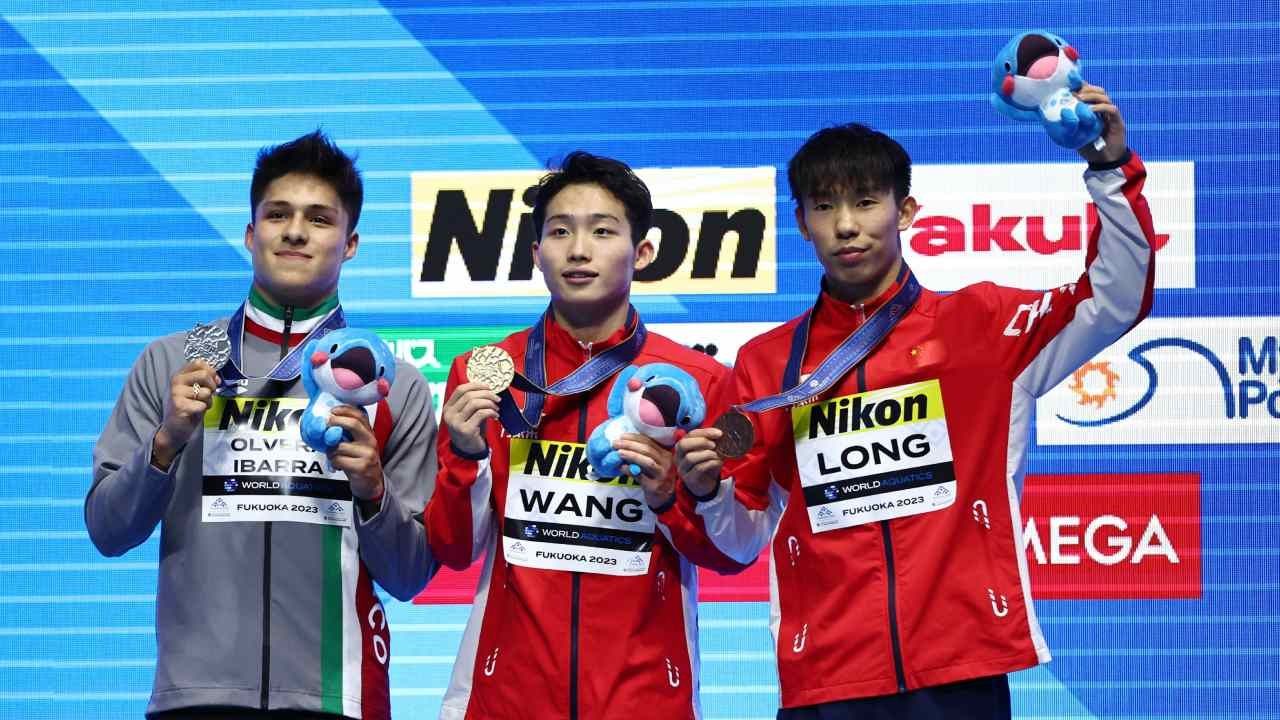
[676,86,1155,719]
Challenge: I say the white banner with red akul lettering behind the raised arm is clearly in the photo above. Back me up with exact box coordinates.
[902,161,1196,291]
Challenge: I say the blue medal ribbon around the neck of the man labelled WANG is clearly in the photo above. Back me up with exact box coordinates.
[498,306,648,436]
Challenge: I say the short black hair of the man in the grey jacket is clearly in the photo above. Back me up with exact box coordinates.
[248,129,365,232]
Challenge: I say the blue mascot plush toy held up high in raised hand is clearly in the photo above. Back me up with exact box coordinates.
[991,29,1103,150]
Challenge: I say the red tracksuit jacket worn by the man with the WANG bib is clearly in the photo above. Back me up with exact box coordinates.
[426,313,728,720]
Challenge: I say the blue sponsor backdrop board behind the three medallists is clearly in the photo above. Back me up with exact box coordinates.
[0,0,1280,719]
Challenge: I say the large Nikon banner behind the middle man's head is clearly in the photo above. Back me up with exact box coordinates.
[410,165,777,297]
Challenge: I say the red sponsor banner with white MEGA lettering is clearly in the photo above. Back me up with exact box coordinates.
[1008,473,1201,600]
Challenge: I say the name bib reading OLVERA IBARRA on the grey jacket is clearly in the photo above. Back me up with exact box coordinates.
[201,395,360,527]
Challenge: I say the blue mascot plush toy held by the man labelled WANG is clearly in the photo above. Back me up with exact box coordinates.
[586,363,707,478]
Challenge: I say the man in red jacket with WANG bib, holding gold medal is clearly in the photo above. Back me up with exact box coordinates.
[426,152,727,720]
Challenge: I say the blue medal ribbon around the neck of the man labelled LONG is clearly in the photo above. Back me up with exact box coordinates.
[739,263,922,413]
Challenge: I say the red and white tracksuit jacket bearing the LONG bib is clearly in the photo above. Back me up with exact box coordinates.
[677,155,1155,707]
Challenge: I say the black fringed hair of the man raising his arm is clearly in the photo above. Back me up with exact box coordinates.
[787,123,911,202]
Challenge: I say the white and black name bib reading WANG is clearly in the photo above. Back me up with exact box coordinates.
[502,438,657,575]
